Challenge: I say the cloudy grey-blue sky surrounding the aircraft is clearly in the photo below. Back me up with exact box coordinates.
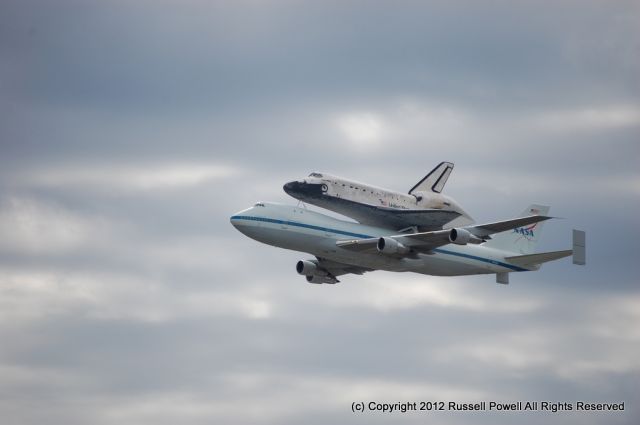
[0,0,640,425]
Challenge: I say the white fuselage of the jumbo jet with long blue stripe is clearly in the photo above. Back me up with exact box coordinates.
[231,202,529,276]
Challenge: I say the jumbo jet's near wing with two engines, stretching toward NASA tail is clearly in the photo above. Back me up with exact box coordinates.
[336,215,551,255]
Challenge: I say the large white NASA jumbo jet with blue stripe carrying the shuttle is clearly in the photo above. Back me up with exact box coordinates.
[230,202,586,284]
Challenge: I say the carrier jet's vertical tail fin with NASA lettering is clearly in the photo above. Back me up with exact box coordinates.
[485,204,549,254]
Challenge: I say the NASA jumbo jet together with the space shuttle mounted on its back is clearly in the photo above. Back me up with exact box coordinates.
[230,162,586,284]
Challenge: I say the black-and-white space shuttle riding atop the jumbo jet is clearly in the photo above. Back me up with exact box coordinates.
[283,162,473,231]
